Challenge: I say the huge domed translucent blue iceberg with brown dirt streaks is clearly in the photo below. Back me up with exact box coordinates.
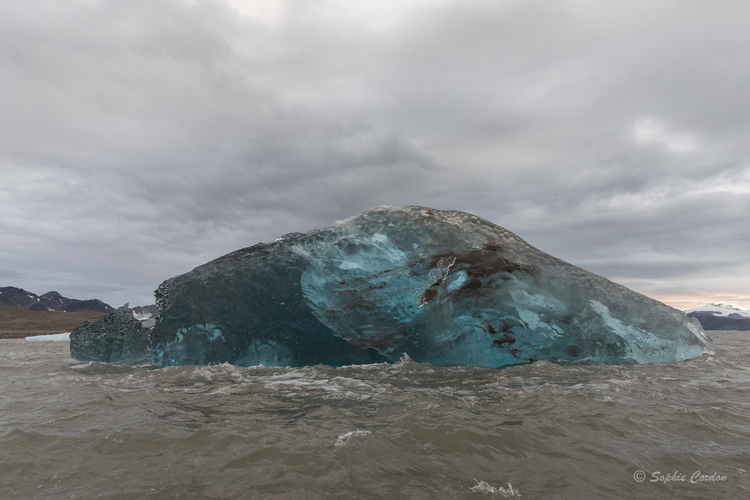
[148,206,713,368]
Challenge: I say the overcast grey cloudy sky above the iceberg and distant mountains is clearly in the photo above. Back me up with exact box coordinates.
[0,0,750,308]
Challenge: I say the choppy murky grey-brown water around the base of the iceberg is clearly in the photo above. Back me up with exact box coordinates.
[0,332,750,500]
